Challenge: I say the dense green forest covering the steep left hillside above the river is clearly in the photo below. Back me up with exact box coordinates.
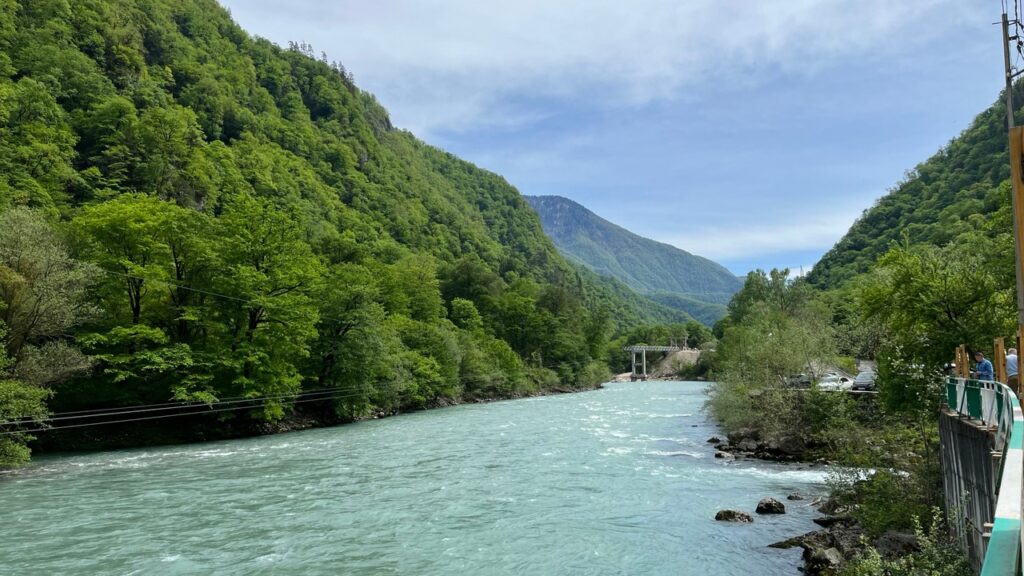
[0,0,687,464]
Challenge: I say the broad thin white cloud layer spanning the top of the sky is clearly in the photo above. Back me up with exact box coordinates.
[222,0,980,136]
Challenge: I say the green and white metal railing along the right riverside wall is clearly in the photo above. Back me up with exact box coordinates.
[946,378,1024,576]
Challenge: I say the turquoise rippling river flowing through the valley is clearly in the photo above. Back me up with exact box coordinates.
[0,382,824,575]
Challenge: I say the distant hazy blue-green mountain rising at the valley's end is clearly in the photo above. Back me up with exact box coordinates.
[525,196,742,324]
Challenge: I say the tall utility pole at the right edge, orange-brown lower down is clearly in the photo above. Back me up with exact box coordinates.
[1001,12,1024,346]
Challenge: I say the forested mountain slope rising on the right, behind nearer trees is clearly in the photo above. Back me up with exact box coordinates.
[807,84,1024,288]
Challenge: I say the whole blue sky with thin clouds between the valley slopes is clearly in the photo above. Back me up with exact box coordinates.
[221,0,1002,274]
